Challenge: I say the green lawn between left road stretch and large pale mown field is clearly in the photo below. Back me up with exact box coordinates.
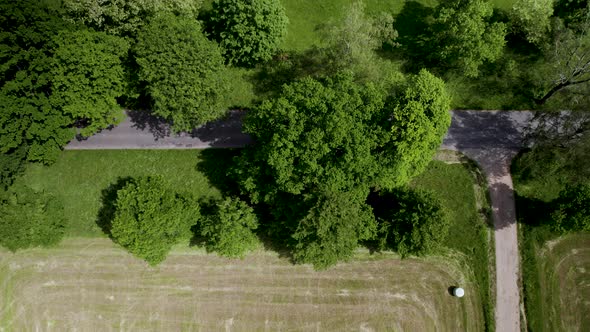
[20,150,235,236]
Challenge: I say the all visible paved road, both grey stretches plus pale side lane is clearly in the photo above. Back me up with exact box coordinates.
[66,111,532,332]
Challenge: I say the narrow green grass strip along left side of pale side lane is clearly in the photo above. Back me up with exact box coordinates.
[413,161,494,330]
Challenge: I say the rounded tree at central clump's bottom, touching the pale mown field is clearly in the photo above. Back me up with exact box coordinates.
[293,193,376,270]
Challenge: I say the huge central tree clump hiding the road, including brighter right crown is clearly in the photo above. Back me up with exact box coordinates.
[235,71,450,267]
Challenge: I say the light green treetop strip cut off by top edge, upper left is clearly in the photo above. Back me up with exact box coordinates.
[63,0,201,36]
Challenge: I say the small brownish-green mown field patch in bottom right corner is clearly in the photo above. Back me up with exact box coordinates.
[531,234,590,331]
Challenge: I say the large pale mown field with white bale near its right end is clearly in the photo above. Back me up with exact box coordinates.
[0,238,483,331]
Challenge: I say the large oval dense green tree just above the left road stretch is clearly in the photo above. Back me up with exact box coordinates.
[133,13,228,131]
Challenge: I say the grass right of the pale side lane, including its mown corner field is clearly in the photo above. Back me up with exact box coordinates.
[512,154,590,331]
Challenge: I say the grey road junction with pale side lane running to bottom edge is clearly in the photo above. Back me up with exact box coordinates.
[442,111,533,332]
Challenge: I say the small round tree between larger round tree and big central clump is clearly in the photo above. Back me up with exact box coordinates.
[200,198,259,258]
